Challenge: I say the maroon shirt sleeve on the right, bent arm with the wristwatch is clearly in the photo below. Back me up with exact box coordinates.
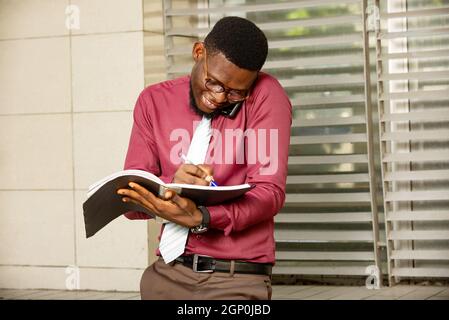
[208,81,292,235]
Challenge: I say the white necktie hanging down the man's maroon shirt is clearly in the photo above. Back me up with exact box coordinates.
[159,117,212,263]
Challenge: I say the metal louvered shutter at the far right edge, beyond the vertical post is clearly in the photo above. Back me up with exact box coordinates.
[376,0,449,283]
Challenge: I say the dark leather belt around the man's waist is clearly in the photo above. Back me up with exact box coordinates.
[175,254,272,275]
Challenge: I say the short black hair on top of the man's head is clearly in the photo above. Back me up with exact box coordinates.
[204,17,268,71]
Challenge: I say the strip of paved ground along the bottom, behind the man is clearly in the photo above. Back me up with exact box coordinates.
[0,285,449,300]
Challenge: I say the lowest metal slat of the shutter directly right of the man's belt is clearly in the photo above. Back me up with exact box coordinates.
[273,266,366,276]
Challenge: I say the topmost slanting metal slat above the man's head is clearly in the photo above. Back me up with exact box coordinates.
[165,0,359,16]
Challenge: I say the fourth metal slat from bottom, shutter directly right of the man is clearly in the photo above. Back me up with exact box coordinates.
[274,212,371,223]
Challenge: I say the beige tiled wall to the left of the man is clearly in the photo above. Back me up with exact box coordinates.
[0,0,165,290]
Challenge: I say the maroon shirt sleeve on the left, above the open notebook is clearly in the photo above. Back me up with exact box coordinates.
[124,91,160,220]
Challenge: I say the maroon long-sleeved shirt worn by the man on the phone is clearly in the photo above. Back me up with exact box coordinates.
[125,73,292,263]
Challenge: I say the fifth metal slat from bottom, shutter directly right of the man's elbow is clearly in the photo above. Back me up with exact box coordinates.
[285,192,370,205]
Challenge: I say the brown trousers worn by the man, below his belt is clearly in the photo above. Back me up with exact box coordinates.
[140,258,272,300]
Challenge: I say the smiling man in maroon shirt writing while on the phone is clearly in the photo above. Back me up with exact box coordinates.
[118,17,292,299]
